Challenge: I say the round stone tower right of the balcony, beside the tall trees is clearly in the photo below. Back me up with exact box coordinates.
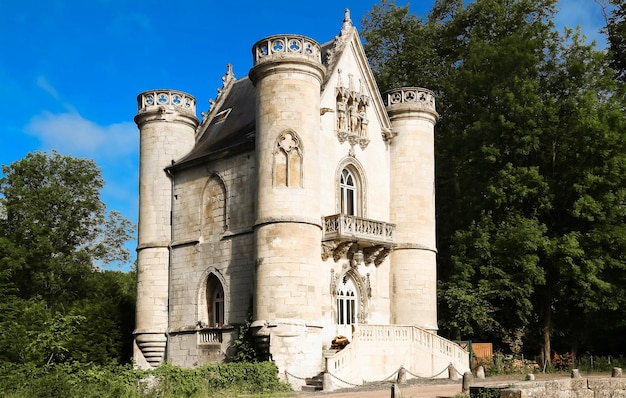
[383,87,438,333]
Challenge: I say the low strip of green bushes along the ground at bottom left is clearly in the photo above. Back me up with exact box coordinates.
[0,362,290,398]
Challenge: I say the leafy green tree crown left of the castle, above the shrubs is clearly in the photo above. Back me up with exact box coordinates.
[0,152,133,308]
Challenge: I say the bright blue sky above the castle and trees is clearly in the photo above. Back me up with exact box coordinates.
[0,0,605,270]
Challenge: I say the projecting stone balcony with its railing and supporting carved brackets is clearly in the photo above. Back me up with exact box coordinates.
[322,214,396,265]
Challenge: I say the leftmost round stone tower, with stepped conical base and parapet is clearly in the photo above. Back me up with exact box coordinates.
[133,90,198,368]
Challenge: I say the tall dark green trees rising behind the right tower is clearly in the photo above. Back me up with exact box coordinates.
[364,0,626,358]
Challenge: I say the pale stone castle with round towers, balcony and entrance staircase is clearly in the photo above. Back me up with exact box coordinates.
[134,10,469,388]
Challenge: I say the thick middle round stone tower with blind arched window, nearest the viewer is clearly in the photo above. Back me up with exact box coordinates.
[249,35,324,375]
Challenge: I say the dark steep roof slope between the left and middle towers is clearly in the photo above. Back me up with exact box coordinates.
[170,77,256,170]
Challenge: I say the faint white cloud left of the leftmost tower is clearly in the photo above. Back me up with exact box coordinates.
[26,111,139,159]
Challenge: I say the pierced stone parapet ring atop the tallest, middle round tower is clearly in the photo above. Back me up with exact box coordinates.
[252,35,322,65]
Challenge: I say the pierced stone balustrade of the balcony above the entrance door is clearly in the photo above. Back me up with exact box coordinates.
[322,214,396,244]
